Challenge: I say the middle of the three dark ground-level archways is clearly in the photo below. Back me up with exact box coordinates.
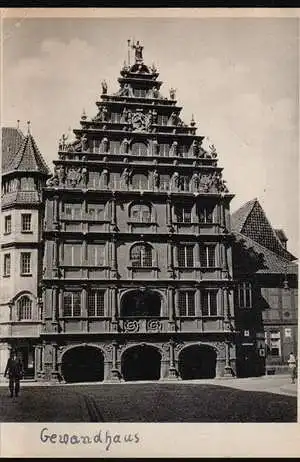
[121,345,161,381]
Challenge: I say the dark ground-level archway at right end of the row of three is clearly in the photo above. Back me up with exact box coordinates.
[178,345,217,380]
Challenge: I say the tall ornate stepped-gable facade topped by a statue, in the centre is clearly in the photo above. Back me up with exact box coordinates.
[42,43,236,381]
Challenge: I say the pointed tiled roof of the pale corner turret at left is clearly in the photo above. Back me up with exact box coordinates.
[3,130,49,175]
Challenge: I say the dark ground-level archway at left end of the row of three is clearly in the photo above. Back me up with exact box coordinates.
[61,346,104,382]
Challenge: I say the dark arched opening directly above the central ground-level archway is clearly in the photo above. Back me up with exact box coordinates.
[121,290,161,317]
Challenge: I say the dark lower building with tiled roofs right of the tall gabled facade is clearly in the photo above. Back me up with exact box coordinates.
[231,199,298,376]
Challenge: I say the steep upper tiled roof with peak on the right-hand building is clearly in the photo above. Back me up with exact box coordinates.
[231,199,295,261]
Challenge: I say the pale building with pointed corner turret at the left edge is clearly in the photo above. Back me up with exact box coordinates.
[0,124,50,377]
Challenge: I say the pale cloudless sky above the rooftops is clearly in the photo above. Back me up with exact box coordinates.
[1,18,299,255]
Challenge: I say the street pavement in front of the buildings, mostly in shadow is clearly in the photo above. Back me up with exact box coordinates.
[0,376,297,422]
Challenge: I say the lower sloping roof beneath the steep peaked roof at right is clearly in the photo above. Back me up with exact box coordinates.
[233,232,298,274]
